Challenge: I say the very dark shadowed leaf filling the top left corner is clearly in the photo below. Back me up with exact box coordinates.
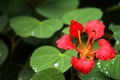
[0,0,29,15]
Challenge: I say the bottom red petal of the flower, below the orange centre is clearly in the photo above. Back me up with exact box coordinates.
[71,56,94,74]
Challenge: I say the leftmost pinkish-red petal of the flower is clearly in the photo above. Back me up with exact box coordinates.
[56,35,74,50]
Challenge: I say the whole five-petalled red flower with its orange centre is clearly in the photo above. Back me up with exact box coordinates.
[56,20,116,74]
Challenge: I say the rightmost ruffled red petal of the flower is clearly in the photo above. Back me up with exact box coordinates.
[95,39,116,60]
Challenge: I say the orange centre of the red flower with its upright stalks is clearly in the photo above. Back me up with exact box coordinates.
[75,30,95,60]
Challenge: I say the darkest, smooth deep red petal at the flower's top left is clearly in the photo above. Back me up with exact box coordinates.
[69,20,83,37]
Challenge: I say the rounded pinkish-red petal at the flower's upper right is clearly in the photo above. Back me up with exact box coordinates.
[84,20,105,39]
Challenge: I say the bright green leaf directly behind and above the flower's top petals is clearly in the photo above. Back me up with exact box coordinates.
[62,8,102,25]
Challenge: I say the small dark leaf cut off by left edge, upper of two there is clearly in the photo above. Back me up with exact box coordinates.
[0,14,8,32]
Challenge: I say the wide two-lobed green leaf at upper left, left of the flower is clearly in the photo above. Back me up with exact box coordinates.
[10,16,63,38]
